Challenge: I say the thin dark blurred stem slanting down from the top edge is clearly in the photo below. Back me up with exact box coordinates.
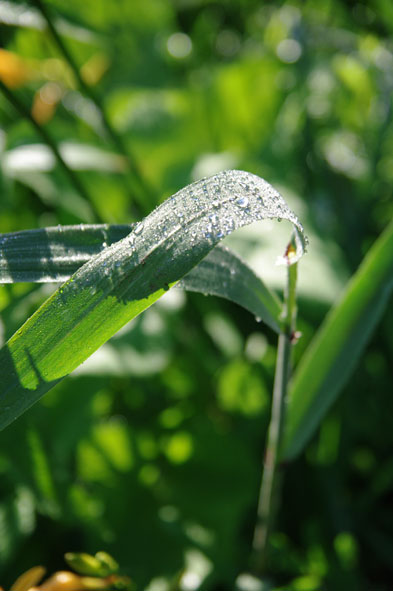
[32,0,152,213]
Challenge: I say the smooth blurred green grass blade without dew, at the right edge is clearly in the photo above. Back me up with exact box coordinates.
[281,223,393,459]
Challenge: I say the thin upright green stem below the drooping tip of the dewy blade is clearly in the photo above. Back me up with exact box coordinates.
[253,244,297,574]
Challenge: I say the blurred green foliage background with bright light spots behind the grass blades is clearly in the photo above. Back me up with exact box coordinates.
[0,0,393,591]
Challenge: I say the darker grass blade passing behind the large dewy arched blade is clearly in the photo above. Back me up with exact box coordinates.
[0,224,281,332]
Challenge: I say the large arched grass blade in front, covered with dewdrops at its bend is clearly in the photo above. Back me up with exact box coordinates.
[0,171,304,427]
